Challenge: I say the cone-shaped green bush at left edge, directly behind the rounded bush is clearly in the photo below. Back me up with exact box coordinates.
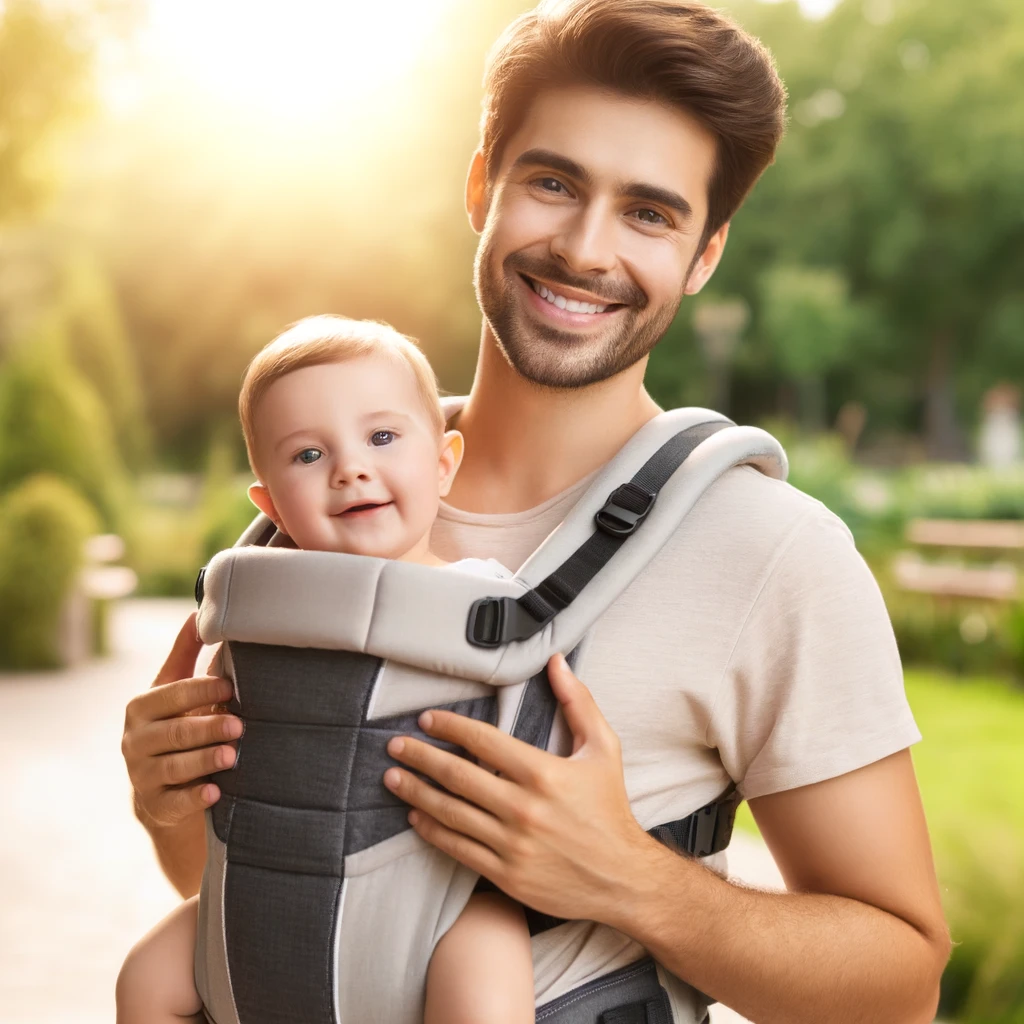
[0,346,127,530]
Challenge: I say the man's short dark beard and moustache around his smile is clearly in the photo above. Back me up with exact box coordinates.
[474,234,683,389]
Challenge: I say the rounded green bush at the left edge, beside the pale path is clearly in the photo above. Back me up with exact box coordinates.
[0,474,98,669]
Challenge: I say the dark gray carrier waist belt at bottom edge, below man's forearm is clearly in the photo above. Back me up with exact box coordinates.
[537,957,672,1024]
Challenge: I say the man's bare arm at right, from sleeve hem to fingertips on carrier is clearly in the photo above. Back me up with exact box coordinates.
[385,659,949,1024]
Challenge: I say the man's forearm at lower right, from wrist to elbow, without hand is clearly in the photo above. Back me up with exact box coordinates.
[609,842,945,1024]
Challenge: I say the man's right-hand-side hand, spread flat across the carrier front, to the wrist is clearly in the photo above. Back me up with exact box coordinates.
[384,654,656,924]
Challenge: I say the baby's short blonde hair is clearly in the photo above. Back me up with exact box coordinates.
[239,313,444,471]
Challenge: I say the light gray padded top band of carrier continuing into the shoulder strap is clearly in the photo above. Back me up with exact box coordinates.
[199,409,786,685]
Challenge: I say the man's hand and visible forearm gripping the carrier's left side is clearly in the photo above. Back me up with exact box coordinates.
[121,614,242,897]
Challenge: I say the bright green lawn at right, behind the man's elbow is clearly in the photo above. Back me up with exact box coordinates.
[737,670,1024,1024]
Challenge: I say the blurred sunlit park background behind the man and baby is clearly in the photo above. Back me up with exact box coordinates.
[0,0,1024,1024]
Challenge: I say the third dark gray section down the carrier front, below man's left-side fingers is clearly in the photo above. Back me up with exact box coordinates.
[214,797,347,878]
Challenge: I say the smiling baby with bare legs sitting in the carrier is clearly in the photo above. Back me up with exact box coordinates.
[117,316,534,1024]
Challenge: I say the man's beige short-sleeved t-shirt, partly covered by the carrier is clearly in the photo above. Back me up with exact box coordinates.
[432,467,921,1022]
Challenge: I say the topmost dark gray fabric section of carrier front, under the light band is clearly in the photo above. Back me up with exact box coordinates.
[228,642,381,725]
